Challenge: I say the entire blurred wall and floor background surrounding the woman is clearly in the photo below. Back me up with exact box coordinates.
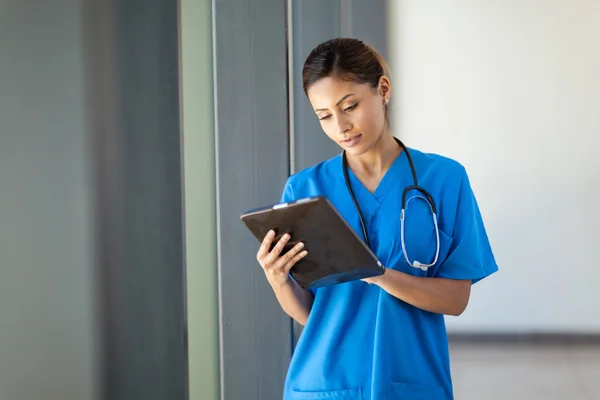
[0,0,600,400]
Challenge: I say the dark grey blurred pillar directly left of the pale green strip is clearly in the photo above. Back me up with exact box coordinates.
[86,0,187,400]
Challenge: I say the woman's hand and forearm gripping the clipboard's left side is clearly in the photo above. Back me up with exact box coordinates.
[256,231,314,325]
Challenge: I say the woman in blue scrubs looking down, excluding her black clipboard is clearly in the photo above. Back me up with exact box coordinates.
[257,39,498,400]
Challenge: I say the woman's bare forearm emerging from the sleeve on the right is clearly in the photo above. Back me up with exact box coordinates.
[372,269,471,316]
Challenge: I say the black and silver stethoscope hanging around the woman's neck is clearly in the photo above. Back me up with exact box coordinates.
[342,138,440,271]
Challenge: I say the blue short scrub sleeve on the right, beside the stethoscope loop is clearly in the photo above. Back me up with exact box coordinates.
[436,169,498,283]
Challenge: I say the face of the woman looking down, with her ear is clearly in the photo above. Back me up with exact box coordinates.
[307,77,390,155]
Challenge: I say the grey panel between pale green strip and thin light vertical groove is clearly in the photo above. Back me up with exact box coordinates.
[213,0,291,400]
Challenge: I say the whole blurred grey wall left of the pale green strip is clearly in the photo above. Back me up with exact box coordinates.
[0,0,187,400]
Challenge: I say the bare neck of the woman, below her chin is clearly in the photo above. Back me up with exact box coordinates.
[346,131,402,176]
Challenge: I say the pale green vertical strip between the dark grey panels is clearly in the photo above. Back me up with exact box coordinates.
[180,0,219,400]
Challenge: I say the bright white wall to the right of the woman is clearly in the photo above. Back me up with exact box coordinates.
[390,0,600,333]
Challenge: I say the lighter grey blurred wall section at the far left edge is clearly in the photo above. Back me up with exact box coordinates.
[0,0,96,400]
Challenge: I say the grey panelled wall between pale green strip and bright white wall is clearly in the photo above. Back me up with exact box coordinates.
[213,0,387,400]
